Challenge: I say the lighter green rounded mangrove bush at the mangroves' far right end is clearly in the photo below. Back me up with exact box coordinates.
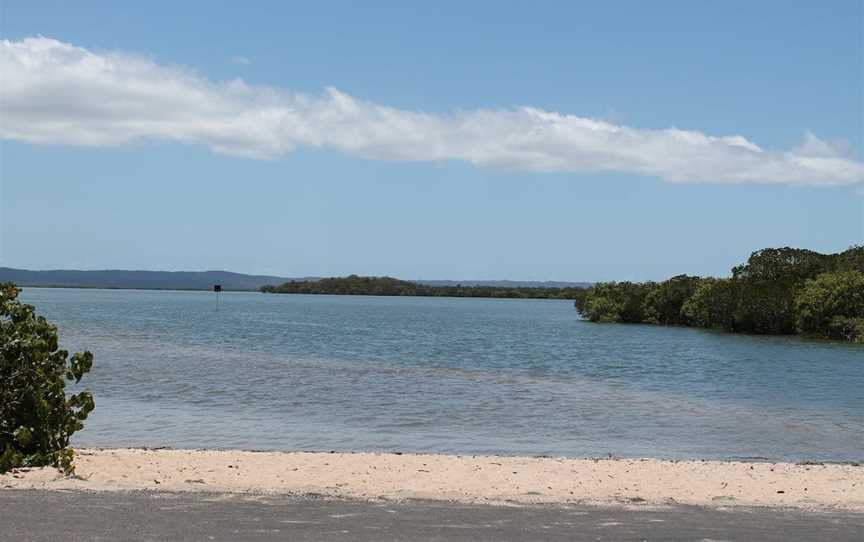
[795,271,864,342]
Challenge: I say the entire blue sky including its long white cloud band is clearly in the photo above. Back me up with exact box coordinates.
[0,0,864,281]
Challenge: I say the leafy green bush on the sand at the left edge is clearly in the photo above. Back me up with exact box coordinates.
[0,283,94,473]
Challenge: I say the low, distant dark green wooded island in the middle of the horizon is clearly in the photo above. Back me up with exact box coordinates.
[261,275,582,299]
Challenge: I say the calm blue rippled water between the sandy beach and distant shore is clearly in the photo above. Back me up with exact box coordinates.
[22,289,864,461]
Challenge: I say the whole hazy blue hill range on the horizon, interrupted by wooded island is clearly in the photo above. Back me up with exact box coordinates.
[0,267,591,291]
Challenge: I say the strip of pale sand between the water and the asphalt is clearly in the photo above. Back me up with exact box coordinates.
[0,449,864,511]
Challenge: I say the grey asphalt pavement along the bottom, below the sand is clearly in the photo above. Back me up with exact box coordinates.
[0,490,864,542]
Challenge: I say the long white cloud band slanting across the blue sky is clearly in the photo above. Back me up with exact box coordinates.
[0,37,864,185]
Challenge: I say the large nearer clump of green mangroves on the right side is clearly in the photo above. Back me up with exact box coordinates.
[576,247,864,343]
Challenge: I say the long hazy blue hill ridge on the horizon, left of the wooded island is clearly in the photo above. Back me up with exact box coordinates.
[0,267,303,291]
